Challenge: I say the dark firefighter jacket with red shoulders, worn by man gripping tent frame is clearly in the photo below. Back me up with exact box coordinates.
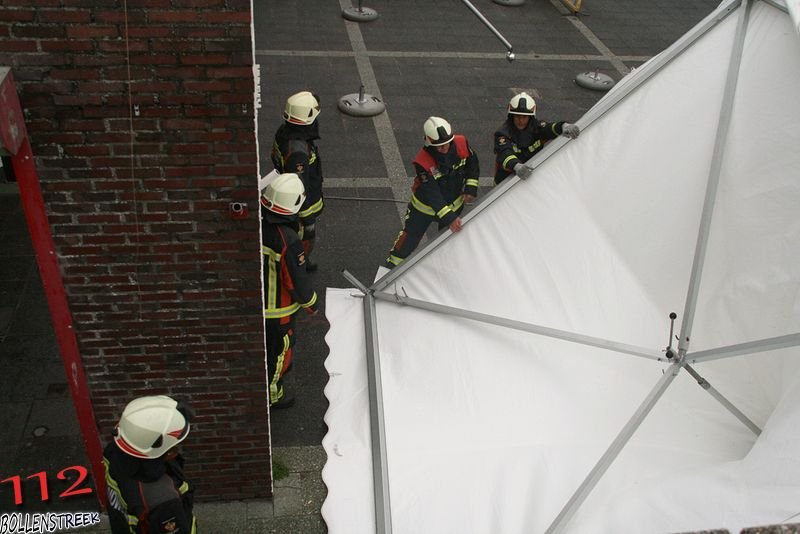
[411,135,480,225]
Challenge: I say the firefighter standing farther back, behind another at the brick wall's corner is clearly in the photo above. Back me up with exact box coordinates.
[270,91,324,272]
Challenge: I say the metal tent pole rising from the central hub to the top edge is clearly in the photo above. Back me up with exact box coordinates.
[678,0,753,355]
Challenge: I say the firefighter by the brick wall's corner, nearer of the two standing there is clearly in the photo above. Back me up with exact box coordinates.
[261,173,317,408]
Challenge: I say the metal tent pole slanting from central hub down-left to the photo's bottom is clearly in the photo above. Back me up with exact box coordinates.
[545,362,682,534]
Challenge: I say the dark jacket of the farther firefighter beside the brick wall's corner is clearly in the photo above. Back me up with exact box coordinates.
[270,122,323,219]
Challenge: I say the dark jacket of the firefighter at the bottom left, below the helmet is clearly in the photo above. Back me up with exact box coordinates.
[103,441,196,534]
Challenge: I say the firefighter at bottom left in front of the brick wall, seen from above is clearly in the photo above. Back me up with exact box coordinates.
[103,395,197,534]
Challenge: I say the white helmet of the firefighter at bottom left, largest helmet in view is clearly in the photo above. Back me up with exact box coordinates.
[114,395,189,459]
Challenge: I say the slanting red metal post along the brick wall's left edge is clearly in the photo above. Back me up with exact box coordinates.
[0,69,106,507]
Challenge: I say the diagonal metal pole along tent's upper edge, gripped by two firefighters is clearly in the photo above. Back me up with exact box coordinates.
[371,0,742,291]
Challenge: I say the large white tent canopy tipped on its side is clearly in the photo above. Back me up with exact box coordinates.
[322,1,800,534]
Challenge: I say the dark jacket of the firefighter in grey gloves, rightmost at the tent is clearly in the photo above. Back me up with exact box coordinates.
[494,116,564,184]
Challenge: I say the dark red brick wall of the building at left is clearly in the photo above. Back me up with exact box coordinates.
[0,0,270,499]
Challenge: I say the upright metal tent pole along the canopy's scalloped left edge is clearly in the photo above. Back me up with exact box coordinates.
[342,270,392,534]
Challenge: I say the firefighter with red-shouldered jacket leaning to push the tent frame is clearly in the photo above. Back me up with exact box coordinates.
[385,117,480,269]
